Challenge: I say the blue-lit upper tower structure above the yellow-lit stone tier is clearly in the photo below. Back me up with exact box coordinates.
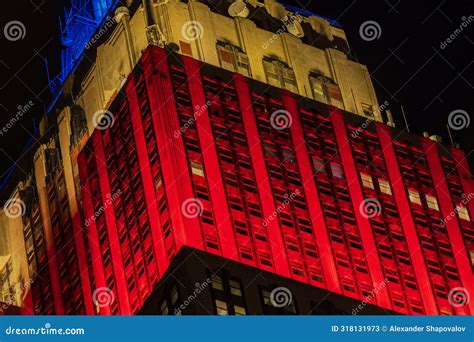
[46,0,118,95]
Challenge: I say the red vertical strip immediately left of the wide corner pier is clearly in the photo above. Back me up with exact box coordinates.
[125,77,169,277]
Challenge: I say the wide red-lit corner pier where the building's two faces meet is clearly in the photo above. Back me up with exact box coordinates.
[142,47,203,251]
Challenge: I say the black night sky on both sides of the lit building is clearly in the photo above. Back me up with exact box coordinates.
[0,0,474,184]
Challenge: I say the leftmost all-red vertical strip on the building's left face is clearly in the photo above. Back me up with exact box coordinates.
[77,152,111,315]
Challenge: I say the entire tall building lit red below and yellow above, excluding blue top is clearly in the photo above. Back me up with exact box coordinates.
[0,1,474,315]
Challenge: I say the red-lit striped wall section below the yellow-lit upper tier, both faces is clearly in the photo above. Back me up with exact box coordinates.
[78,47,474,315]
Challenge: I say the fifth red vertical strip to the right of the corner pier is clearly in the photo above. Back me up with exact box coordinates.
[376,123,438,315]
